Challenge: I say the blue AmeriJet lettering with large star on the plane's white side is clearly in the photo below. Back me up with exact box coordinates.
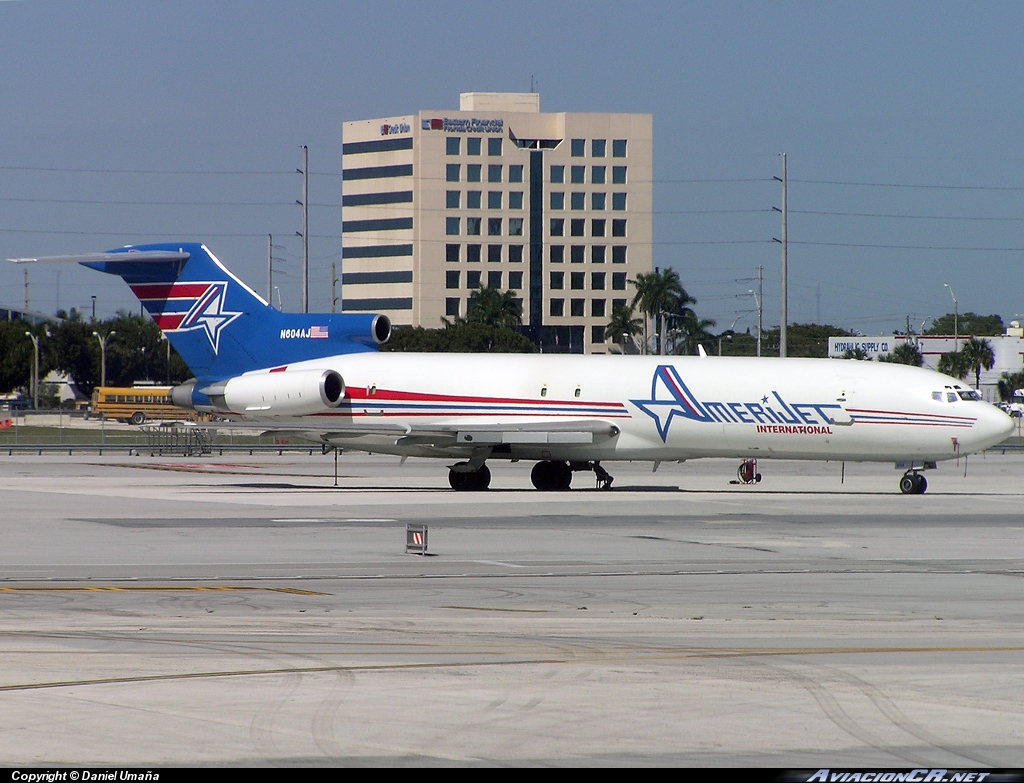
[630,364,843,441]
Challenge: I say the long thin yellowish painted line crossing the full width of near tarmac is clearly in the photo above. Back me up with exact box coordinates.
[0,647,1024,693]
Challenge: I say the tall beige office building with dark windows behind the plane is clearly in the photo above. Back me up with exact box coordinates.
[342,92,652,353]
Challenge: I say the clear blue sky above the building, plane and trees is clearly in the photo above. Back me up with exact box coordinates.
[0,0,1024,334]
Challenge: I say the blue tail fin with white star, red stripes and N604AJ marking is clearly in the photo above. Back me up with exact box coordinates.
[83,243,391,381]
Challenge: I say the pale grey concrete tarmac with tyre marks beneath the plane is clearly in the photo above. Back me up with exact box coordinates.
[0,452,1024,769]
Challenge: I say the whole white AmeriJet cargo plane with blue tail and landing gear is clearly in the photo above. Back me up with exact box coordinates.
[12,244,1013,494]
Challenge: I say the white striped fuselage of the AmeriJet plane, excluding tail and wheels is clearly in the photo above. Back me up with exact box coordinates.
[220,352,1012,462]
